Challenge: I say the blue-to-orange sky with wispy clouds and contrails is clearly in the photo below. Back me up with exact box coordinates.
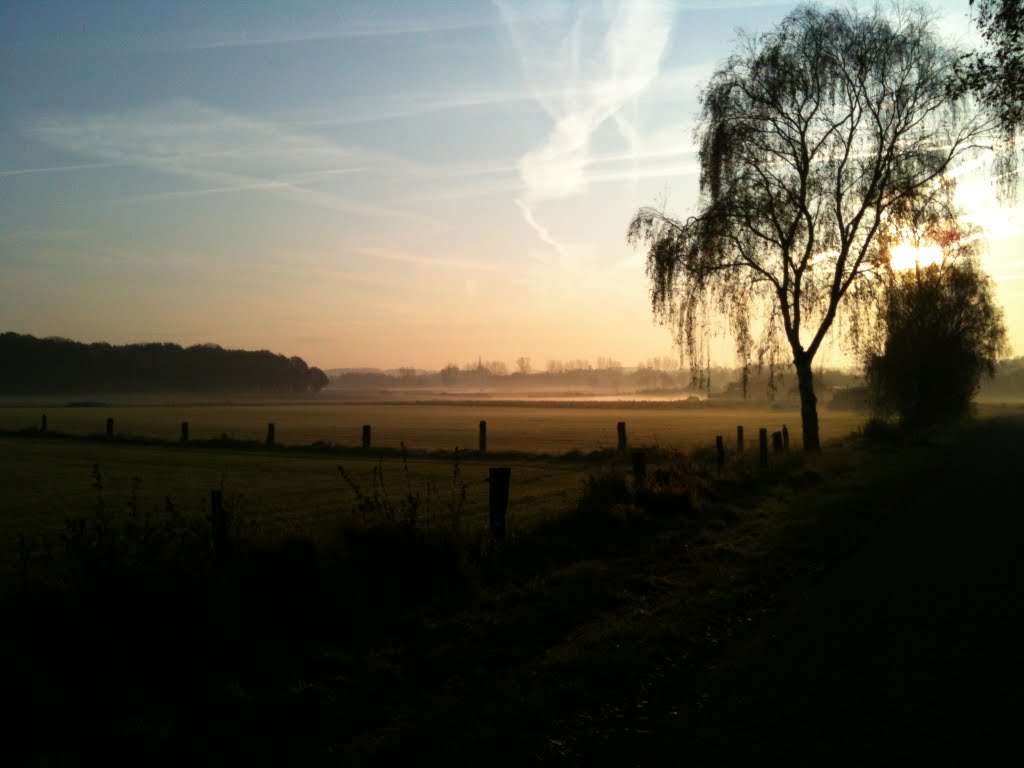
[0,0,1024,370]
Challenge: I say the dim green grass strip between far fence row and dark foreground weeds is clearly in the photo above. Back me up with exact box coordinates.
[0,437,598,543]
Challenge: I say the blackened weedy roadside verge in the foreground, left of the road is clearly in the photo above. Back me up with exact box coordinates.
[0,417,995,765]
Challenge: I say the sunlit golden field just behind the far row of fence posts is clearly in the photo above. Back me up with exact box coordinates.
[0,402,863,454]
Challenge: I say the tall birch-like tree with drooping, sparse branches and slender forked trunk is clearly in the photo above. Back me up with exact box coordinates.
[628,5,987,451]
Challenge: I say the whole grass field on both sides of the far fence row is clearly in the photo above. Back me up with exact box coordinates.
[0,403,862,585]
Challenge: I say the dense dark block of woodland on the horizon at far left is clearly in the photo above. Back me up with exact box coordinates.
[0,333,328,394]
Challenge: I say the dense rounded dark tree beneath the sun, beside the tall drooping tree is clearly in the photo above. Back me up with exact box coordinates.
[865,259,1007,428]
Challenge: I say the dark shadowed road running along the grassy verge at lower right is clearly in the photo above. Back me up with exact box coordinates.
[601,419,1024,766]
